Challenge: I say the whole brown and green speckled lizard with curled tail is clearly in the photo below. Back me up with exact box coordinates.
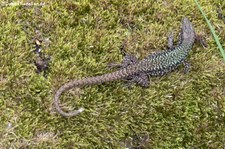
[54,17,195,117]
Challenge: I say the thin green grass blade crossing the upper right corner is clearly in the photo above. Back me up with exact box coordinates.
[195,0,225,61]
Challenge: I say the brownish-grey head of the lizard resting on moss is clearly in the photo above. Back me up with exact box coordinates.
[181,17,195,40]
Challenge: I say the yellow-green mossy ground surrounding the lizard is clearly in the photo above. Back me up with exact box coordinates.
[0,0,225,149]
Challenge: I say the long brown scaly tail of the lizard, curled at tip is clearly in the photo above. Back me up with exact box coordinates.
[54,65,137,117]
